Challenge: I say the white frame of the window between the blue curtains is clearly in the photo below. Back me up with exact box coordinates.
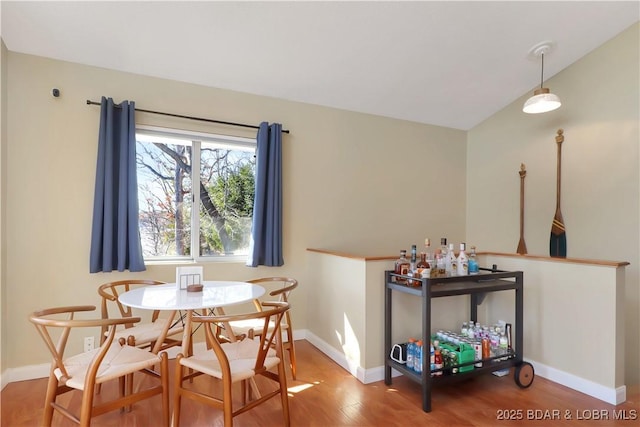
[136,124,257,264]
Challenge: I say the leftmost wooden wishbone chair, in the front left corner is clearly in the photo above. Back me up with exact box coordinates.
[29,305,169,427]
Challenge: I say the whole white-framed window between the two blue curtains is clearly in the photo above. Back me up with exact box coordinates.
[136,126,256,261]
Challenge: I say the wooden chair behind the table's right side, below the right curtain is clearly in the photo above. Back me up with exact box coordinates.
[229,277,298,380]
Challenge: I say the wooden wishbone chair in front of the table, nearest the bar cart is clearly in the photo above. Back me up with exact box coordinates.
[171,302,290,427]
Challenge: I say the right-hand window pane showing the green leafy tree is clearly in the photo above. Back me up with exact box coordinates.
[199,143,255,257]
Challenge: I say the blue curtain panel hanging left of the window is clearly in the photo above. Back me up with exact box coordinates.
[89,96,146,273]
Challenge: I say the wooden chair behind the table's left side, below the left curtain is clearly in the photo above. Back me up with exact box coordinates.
[98,279,184,351]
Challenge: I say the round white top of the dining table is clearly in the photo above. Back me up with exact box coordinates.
[118,281,265,310]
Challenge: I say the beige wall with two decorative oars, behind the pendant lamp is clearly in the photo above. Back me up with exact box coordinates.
[466,24,640,385]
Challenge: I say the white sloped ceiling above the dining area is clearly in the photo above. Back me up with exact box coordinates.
[0,0,640,130]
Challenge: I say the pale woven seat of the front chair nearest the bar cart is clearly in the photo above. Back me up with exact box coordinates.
[180,340,280,382]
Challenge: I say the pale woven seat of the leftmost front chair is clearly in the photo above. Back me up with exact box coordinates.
[54,344,161,390]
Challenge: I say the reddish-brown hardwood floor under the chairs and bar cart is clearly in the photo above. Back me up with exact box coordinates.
[0,340,640,427]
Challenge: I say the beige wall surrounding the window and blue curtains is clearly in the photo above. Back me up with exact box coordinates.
[3,52,466,369]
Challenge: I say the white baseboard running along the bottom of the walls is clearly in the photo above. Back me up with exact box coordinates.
[0,329,627,405]
